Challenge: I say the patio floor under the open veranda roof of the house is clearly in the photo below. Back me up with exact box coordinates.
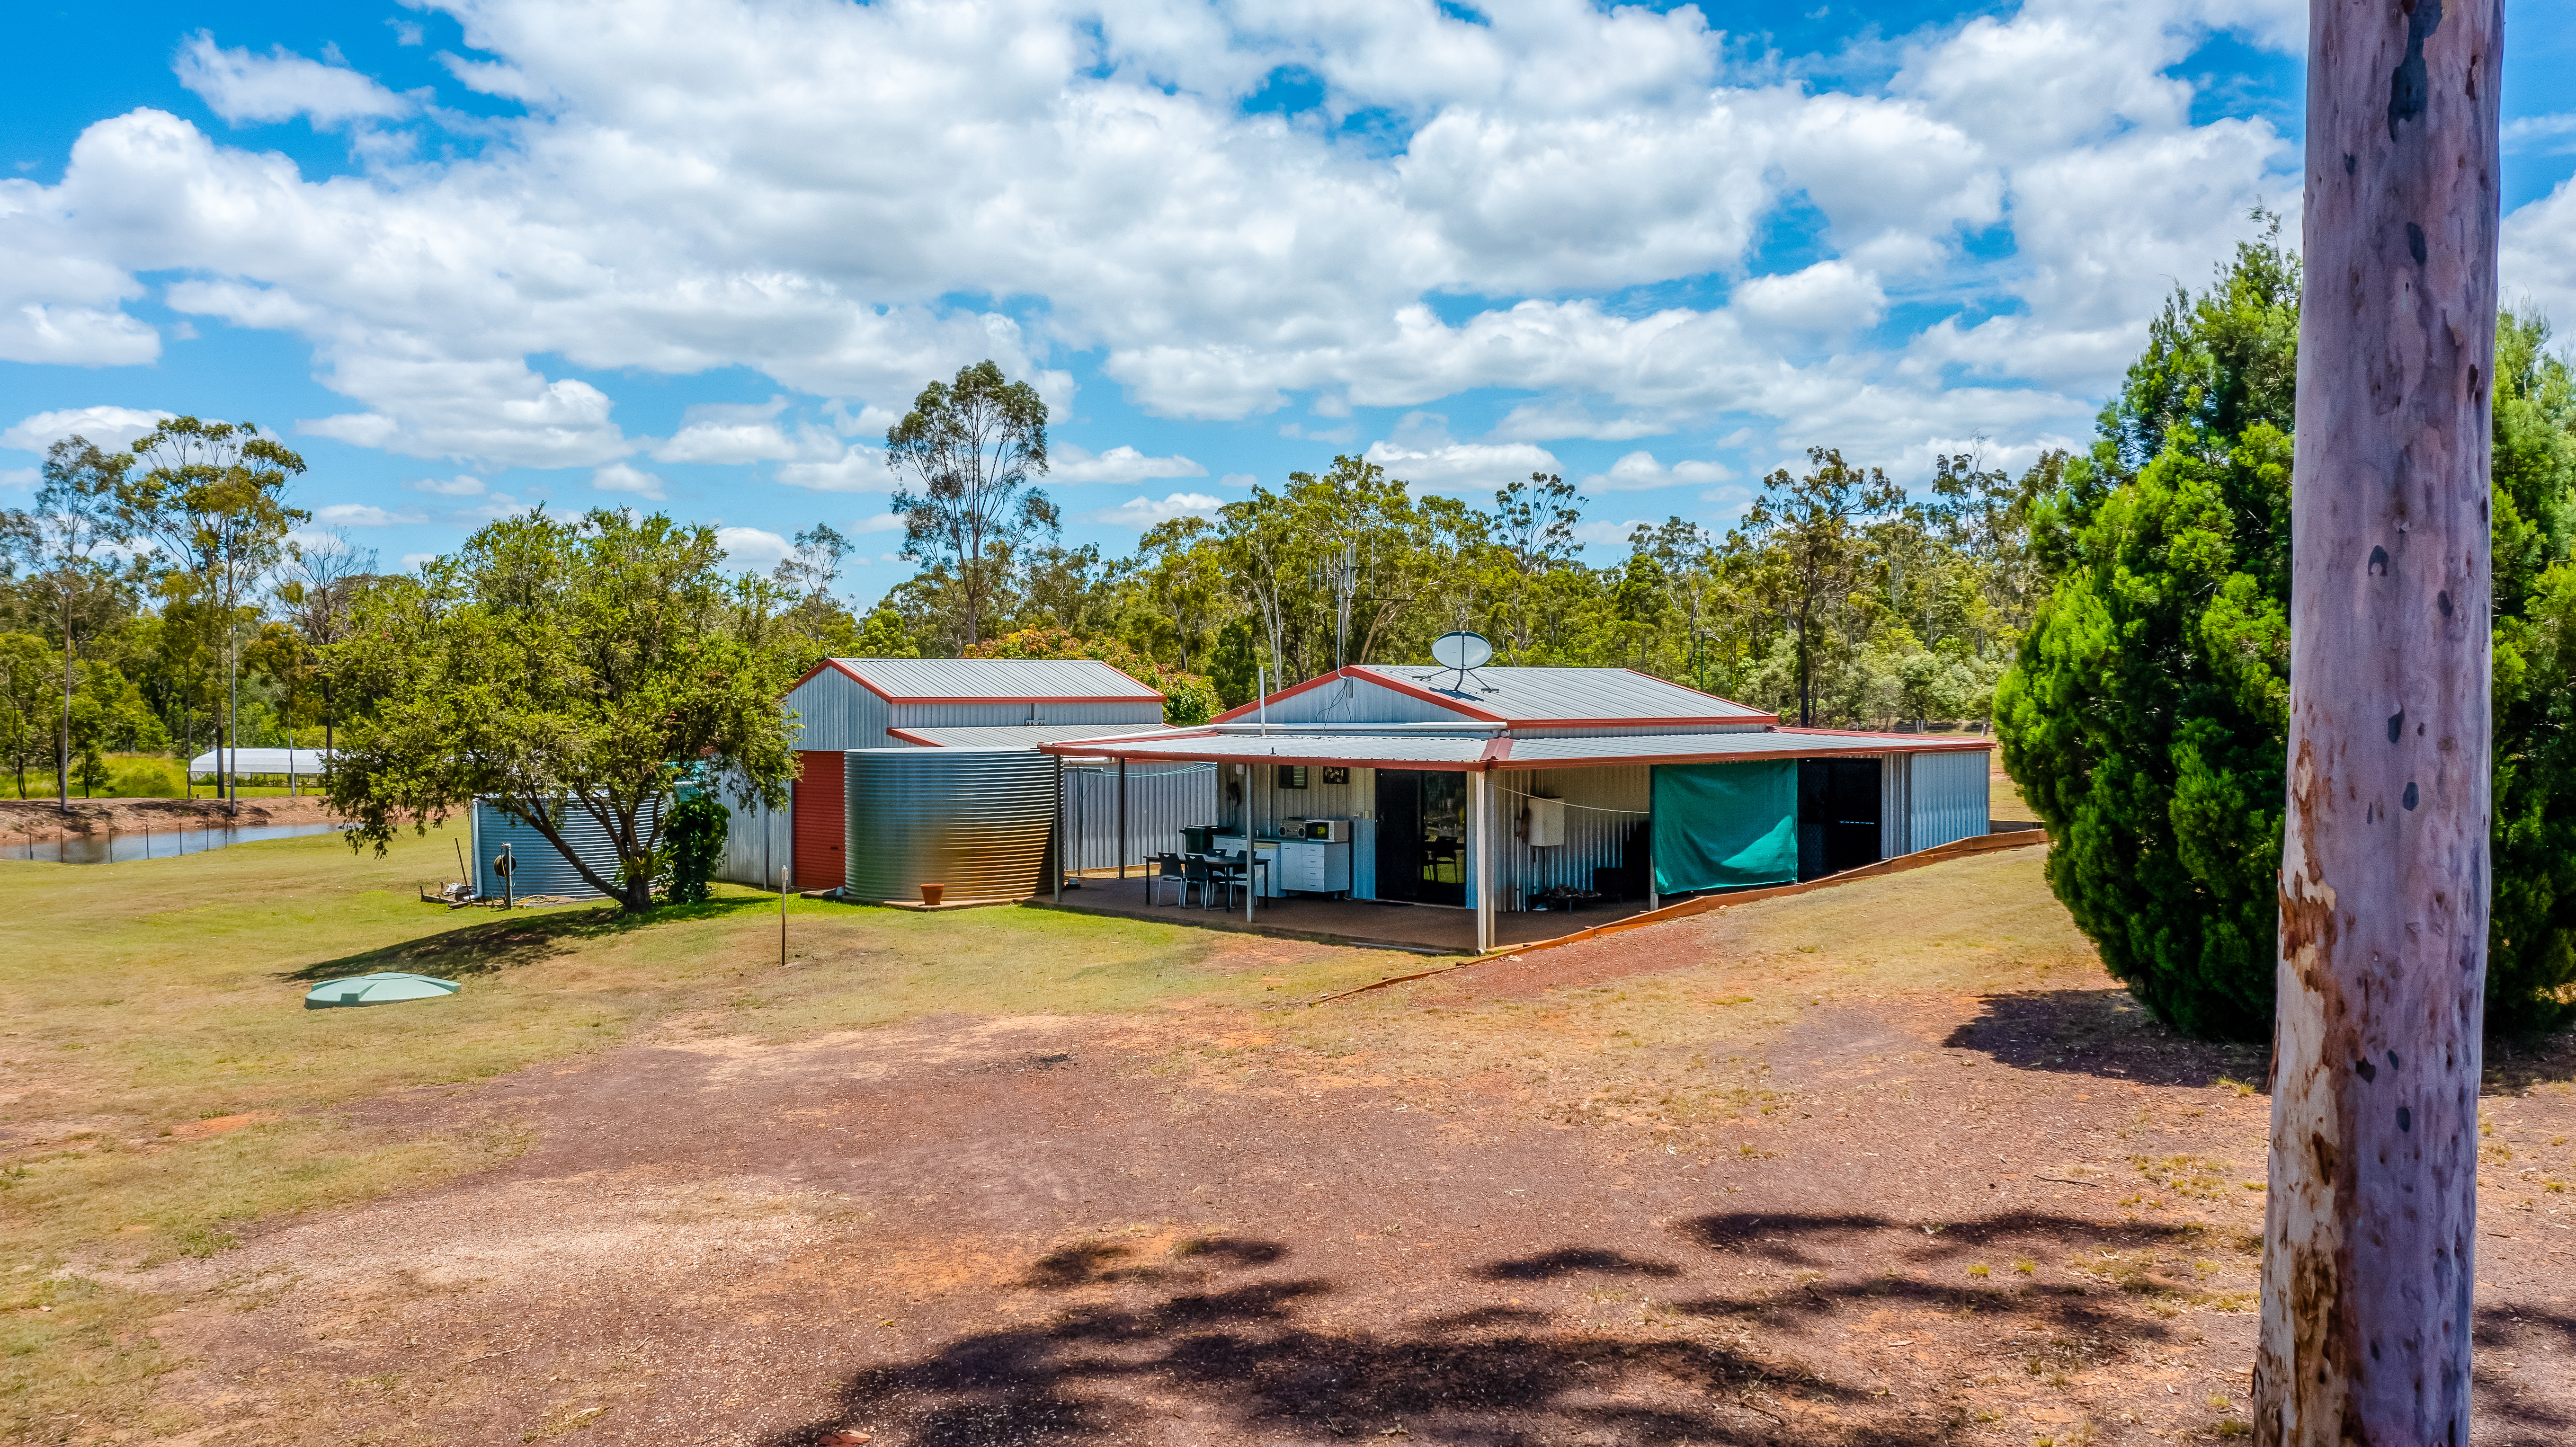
[1030,865,1646,955]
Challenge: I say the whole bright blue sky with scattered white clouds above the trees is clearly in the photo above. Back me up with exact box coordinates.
[0,0,2576,603]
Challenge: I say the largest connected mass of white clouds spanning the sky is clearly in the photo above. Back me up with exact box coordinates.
[0,0,2318,463]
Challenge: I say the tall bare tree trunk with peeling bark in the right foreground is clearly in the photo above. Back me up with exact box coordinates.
[2254,0,2504,1447]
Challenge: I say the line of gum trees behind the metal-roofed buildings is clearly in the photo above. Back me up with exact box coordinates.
[865,363,2066,726]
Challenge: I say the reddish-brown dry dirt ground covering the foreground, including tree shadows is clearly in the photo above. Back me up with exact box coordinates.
[106,865,2576,1447]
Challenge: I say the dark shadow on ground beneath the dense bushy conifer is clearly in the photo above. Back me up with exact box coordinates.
[1943,989,2272,1089]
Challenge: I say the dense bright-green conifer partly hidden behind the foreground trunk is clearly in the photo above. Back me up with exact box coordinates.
[1997,225,2576,1040]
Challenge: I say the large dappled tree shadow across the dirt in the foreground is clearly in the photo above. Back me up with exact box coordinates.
[767,1213,2277,1447]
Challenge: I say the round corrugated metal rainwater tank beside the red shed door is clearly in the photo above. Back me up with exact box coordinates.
[842,749,1056,901]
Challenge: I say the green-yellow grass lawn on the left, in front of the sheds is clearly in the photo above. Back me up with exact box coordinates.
[0,832,1389,1442]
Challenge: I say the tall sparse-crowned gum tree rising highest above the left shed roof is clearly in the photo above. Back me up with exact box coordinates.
[886,361,1059,646]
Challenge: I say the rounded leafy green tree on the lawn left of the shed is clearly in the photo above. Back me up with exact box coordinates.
[327,510,799,912]
